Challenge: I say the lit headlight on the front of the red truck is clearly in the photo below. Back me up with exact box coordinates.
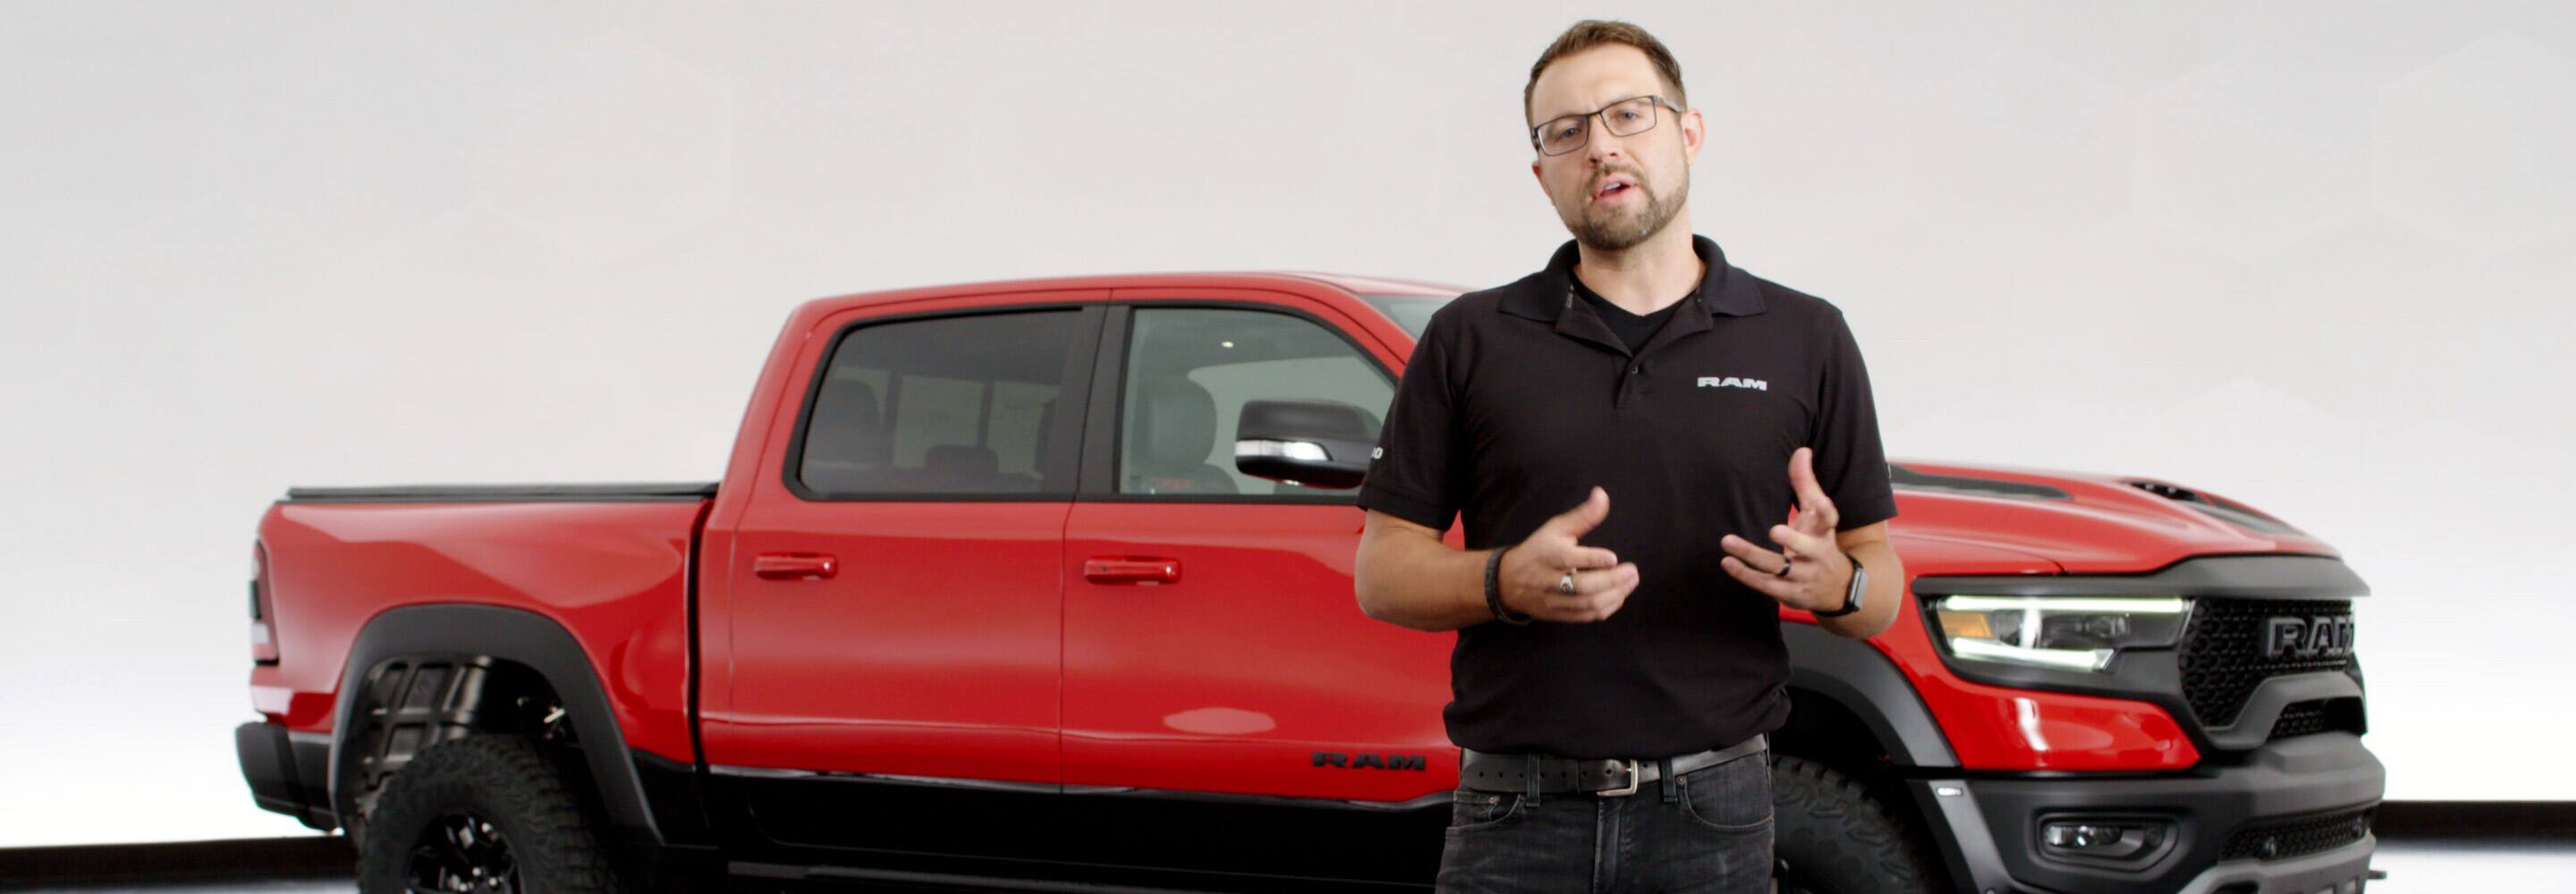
[1932,595,2192,672]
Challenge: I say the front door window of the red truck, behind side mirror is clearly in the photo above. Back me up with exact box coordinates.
[1118,307,1396,502]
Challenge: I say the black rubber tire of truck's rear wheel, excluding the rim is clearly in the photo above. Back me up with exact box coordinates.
[358,734,623,894]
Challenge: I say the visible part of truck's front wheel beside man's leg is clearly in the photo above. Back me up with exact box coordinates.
[1772,757,1940,894]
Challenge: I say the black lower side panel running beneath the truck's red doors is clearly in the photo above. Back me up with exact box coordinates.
[706,765,1450,894]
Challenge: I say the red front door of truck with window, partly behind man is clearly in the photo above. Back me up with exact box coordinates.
[1063,289,1458,876]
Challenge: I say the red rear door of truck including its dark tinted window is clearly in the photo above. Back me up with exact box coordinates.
[703,289,1106,856]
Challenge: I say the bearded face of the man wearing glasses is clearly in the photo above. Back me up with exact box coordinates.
[1530,44,1703,252]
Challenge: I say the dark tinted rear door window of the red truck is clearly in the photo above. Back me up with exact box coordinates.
[793,309,1092,500]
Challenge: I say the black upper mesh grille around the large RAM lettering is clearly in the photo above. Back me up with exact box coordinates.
[2177,598,2351,727]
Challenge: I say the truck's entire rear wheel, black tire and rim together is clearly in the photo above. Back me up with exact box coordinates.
[358,734,621,894]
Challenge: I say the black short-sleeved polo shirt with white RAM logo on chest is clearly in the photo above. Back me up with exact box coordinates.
[1358,237,1896,757]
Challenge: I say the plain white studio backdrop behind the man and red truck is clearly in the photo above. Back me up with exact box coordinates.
[0,0,2576,845]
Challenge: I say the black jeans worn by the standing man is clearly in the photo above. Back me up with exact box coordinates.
[1437,750,1772,894]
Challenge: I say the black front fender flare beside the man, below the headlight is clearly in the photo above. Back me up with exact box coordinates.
[1780,623,1958,768]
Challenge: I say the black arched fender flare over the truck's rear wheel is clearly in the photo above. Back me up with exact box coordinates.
[330,603,662,845]
